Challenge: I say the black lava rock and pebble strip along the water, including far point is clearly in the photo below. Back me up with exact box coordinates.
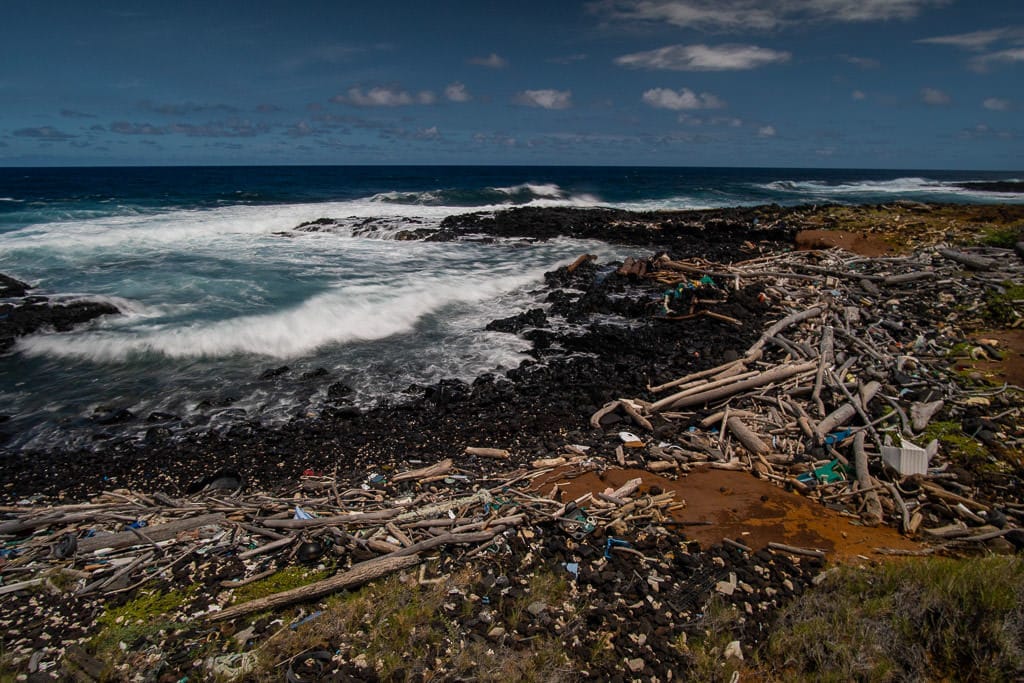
[0,203,1024,502]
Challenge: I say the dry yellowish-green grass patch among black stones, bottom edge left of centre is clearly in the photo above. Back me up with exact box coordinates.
[256,571,586,681]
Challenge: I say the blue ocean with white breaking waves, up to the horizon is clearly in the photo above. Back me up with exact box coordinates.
[0,167,1024,450]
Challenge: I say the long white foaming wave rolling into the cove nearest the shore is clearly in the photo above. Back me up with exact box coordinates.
[16,271,541,362]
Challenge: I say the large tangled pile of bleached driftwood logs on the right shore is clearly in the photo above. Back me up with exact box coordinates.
[591,248,1024,542]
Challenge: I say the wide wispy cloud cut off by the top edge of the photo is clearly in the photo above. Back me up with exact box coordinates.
[590,0,951,32]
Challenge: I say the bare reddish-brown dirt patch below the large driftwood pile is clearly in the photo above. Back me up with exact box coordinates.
[537,469,921,559]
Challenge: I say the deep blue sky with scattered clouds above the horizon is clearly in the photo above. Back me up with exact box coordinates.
[0,0,1024,170]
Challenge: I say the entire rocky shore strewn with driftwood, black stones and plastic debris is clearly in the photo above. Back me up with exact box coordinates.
[0,200,1024,680]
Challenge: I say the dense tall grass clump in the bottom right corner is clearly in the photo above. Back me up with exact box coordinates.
[758,557,1024,681]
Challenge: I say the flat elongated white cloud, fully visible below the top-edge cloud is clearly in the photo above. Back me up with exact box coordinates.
[615,45,792,71]
